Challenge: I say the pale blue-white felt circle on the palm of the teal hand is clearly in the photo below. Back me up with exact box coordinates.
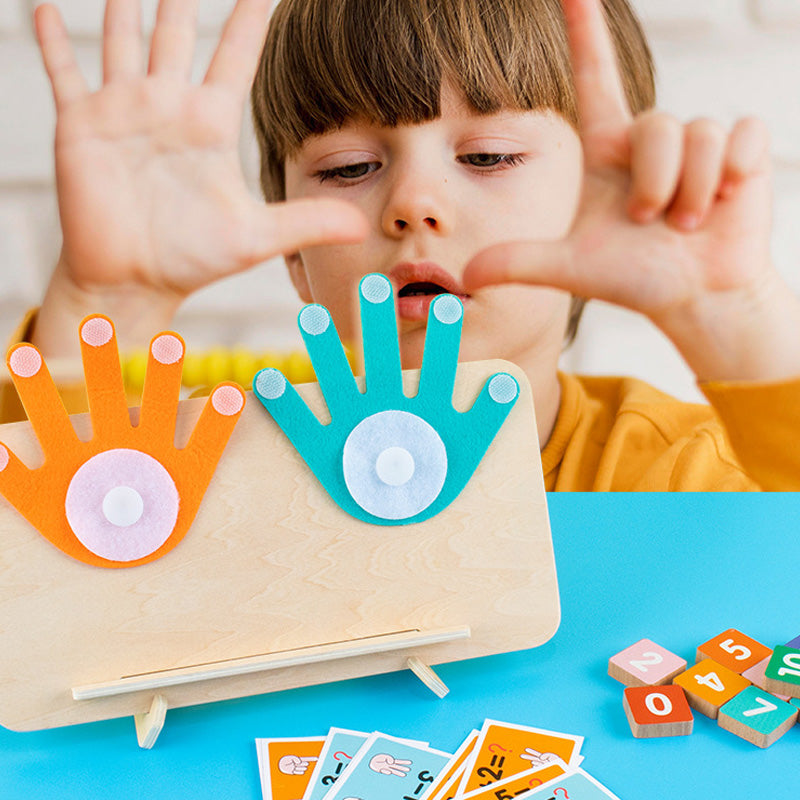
[342,411,447,520]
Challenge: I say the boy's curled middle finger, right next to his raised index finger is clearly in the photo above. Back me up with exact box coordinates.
[628,112,683,223]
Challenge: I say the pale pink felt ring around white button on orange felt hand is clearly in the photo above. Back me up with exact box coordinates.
[65,449,180,561]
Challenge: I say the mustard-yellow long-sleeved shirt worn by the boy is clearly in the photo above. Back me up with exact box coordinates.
[0,312,800,491]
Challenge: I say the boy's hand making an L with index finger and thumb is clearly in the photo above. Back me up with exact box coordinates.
[464,0,800,380]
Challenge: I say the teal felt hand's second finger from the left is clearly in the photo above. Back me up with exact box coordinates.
[297,303,359,417]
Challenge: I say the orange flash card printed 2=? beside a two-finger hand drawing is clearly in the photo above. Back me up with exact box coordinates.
[458,719,583,794]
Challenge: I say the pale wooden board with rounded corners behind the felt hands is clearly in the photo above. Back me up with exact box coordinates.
[0,361,559,730]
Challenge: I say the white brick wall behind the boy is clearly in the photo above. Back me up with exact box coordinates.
[0,0,800,398]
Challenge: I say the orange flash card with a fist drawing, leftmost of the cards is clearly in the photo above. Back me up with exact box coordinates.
[256,736,325,800]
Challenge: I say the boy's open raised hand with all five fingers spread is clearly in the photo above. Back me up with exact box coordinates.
[34,0,366,355]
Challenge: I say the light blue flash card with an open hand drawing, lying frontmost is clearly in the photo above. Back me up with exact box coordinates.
[323,733,452,800]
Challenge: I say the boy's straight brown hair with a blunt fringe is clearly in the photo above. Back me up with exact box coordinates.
[251,0,655,341]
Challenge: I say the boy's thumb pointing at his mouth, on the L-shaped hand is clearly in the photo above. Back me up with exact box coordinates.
[462,239,582,294]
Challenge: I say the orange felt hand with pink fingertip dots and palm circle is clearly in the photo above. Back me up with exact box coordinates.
[0,315,245,567]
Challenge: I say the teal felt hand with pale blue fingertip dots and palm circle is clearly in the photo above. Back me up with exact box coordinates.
[253,274,519,525]
